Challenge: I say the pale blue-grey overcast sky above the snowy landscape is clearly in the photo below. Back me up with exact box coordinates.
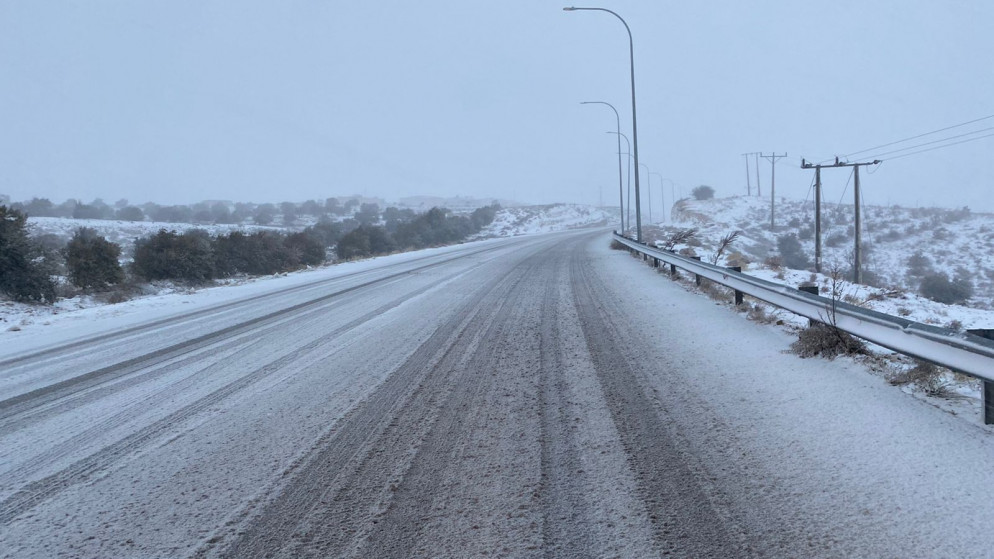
[0,0,994,211]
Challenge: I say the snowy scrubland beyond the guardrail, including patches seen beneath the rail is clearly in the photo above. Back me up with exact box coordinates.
[643,197,994,407]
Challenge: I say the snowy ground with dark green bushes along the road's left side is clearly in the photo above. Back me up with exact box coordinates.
[0,198,611,335]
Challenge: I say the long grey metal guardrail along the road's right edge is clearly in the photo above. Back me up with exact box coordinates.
[613,233,994,424]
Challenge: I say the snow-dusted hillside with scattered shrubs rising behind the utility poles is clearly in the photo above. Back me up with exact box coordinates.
[643,196,994,312]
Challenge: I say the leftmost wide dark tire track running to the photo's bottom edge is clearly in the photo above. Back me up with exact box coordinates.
[207,247,544,557]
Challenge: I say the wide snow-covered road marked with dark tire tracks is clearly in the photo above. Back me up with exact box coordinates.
[0,232,994,558]
